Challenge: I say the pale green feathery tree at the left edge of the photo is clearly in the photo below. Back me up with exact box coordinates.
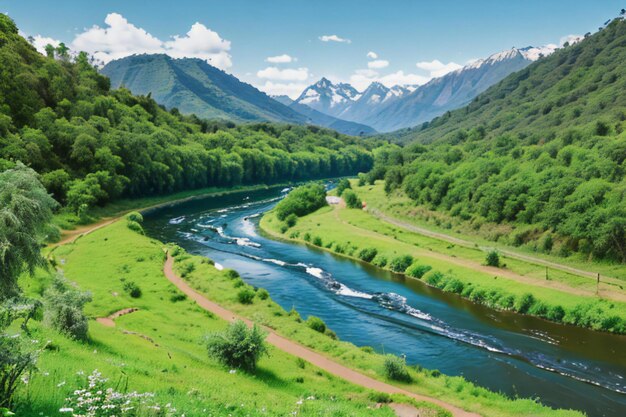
[0,162,57,301]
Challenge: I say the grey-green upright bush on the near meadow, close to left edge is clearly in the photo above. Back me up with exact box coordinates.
[44,276,91,340]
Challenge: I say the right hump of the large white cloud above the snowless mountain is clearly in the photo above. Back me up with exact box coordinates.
[163,22,233,68]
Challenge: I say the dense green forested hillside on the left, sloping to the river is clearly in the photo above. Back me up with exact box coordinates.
[0,14,373,211]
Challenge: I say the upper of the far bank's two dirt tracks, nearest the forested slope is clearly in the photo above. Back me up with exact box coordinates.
[369,209,623,284]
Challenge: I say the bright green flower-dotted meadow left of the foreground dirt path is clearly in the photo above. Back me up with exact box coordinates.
[16,221,424,417]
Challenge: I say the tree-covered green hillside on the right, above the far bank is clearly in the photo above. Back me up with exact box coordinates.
[369,19,626,262]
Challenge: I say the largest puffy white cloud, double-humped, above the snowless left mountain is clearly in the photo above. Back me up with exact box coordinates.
[71,13,232,69]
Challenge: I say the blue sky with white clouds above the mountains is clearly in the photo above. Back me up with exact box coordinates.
[0,0,626,96]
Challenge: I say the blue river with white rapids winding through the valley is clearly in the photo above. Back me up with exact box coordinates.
[144,185,626,417]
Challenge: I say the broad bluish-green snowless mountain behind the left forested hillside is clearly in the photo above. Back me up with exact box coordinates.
[101,54,306,124]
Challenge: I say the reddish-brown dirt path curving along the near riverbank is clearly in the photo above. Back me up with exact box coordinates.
[163,253,479,417]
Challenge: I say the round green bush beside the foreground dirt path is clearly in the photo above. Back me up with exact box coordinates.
[207,320,267,371]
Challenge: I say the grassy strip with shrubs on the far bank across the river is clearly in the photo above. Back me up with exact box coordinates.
[261,188,626,333]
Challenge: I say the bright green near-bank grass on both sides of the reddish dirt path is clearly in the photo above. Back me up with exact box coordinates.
[18,211,580,416]
